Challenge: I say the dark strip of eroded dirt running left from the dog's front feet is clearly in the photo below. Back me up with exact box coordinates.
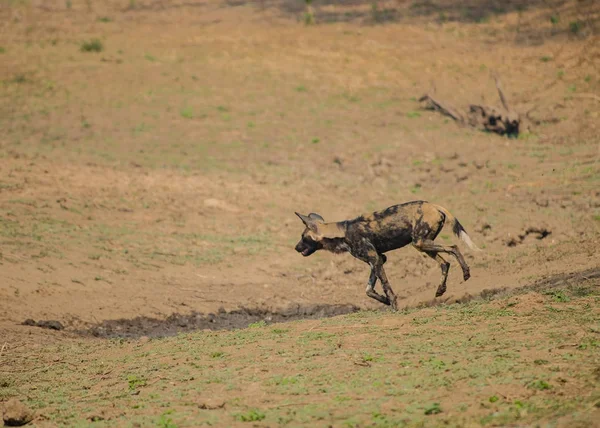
[78,305,359,338]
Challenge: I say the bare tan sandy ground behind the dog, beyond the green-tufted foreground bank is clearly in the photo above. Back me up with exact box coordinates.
[0,1,600,342]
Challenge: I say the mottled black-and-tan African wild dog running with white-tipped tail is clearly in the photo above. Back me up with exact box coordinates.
[296,201,480,309]
